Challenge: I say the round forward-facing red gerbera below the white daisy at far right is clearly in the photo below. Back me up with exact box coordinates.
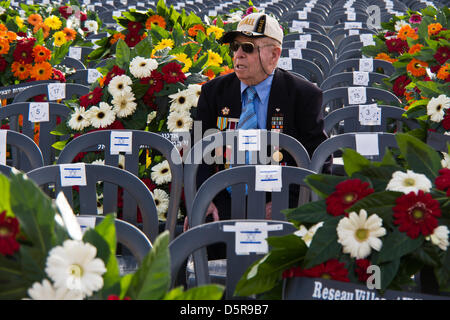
[392,190,441,239]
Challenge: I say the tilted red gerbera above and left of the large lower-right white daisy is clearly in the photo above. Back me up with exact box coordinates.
[326,179,374,216]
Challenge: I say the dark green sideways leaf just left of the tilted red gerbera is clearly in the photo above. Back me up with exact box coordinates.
[281,200,333,224]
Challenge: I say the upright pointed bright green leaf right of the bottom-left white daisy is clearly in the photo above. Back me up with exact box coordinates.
[126,231,170,300]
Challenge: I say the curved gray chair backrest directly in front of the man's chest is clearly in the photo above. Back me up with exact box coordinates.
[184,130,310,216]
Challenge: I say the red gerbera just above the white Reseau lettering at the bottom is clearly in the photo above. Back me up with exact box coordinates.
[282,259,350,282]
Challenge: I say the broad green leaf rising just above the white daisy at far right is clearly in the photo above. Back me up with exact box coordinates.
[395,133,441,180]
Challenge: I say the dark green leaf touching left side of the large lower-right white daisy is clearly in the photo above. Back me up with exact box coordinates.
[304,217,342,269]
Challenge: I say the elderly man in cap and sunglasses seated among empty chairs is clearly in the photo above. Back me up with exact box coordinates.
[190,13,327,226]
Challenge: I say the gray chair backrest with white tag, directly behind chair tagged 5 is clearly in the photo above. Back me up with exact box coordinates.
[13,83,89,103]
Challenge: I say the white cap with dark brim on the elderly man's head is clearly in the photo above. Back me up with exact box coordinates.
[220,12,284,44]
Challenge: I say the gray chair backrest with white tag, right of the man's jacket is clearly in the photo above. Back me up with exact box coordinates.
[309,132,398,172]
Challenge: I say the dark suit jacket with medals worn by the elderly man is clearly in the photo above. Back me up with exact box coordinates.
[194,68,327,219]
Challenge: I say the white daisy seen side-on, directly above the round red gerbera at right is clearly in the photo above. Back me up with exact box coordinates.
[386,170,431,194]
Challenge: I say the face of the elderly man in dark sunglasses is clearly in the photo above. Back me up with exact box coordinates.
[233,35,281,86]
